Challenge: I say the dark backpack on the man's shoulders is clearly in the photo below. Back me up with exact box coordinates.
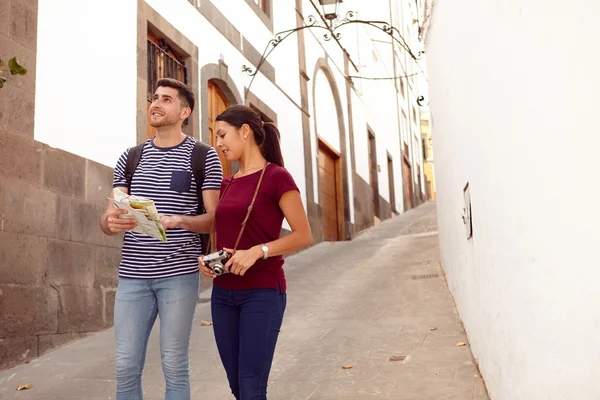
[125,141,211,252]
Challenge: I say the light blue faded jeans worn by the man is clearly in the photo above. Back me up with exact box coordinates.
[115,273,199,400]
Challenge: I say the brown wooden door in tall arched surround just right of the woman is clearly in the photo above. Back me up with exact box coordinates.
[319,143,340,241]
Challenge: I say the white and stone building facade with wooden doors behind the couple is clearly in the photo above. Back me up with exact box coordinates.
[0,0,425,368]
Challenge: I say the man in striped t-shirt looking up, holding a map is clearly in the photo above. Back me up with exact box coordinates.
[100,79,223,400]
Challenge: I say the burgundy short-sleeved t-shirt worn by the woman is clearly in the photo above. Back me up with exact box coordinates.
[214,163,298,292]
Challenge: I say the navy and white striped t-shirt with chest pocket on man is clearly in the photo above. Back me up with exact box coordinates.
[113,136,223,279]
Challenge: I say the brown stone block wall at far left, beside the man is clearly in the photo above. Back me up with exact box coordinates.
[0,0,122,369]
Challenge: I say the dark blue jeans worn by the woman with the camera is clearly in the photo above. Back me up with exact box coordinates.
[211,285,287,400]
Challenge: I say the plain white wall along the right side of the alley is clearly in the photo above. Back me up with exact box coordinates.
[427,0,600,400]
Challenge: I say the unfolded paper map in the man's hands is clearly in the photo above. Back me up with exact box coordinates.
[110,189,167,242]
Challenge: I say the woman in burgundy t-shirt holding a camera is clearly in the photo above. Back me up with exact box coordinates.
[199,106,311,400]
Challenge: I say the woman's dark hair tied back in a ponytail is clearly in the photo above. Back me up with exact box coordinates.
[217,106,283,167]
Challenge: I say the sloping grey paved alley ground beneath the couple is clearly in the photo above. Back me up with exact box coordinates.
[0,203,488,400]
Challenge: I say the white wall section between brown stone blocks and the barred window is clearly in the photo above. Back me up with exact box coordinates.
[34,0,137,166]
